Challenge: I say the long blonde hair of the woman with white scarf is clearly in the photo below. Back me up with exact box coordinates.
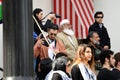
[73,44,95,71]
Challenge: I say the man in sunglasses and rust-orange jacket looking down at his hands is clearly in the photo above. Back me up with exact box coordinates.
[34,23,66,60]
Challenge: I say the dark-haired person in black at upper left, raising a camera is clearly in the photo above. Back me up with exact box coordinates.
[33,8,56,36]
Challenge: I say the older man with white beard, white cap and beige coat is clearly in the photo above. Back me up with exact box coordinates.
[57,19,78,59]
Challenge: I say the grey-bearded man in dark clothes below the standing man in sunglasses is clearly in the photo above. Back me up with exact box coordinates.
[87,31,103,70]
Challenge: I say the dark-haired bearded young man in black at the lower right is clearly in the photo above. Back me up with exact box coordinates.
[97,50,116,80]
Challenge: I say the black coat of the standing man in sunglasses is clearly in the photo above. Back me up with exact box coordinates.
[89,22,111,49]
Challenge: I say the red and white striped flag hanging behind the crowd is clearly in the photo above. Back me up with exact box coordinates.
[53,0,94,39]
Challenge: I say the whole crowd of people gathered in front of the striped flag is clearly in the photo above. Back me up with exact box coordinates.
[33,8,120,80]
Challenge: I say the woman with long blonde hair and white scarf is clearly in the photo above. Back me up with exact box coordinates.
[71,44,96,80]
